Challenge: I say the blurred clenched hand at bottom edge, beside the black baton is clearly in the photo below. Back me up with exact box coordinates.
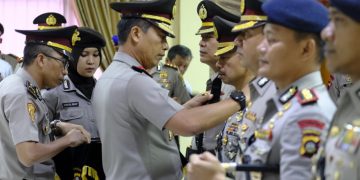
[187,152,225,180]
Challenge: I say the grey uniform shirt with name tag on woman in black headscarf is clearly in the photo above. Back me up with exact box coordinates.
[43,76,99,138]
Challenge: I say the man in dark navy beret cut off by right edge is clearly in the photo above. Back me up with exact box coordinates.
[322,0,360,179]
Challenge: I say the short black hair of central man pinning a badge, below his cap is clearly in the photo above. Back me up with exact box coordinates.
[117,18,152,45]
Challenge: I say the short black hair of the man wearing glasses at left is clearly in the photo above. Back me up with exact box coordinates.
[23,43,55,67]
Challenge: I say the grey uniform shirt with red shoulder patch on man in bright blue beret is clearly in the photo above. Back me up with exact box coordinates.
[243,71,336,179]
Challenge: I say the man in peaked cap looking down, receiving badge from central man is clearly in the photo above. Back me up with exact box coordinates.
[214,16,254,177]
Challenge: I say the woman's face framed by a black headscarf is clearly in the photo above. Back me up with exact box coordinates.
[76,47,100,77]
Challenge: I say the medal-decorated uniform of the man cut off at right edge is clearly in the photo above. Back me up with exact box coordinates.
[325,82,360,180]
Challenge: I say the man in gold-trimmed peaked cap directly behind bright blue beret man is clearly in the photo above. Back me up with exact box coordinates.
[232,0,276,169]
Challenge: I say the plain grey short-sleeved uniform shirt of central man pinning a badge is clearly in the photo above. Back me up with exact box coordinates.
[93,52,183,180]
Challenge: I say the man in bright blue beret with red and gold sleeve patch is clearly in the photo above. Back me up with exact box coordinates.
[187,0,335,179]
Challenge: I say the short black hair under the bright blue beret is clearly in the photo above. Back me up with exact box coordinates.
[295,31,325,64]
